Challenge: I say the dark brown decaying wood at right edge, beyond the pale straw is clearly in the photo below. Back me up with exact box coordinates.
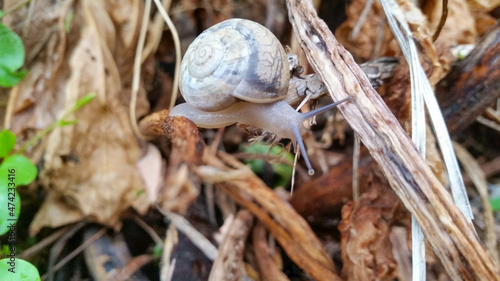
[436,24,500,132]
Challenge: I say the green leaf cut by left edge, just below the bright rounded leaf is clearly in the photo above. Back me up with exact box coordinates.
[0,186,21,235]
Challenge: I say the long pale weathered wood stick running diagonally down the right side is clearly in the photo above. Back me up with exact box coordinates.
[287,0,500,280]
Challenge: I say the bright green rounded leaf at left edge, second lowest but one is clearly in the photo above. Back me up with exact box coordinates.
[0,154,38,188]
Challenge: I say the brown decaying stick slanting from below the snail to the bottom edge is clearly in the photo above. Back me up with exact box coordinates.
[198,152,341,281]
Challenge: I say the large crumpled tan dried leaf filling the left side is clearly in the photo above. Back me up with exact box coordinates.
[4,1,149,235]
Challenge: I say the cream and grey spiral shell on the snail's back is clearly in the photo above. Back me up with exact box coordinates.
[180,19,290,111]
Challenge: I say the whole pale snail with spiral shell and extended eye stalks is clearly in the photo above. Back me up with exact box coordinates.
[170,19,346,175]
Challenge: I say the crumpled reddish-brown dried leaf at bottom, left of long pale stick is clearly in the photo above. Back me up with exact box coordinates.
[339,177,402,280]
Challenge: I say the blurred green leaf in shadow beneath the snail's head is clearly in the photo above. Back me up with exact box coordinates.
[242,142,294,187]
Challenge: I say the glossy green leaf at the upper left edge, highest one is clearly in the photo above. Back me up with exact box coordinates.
[0,23,26,87]
